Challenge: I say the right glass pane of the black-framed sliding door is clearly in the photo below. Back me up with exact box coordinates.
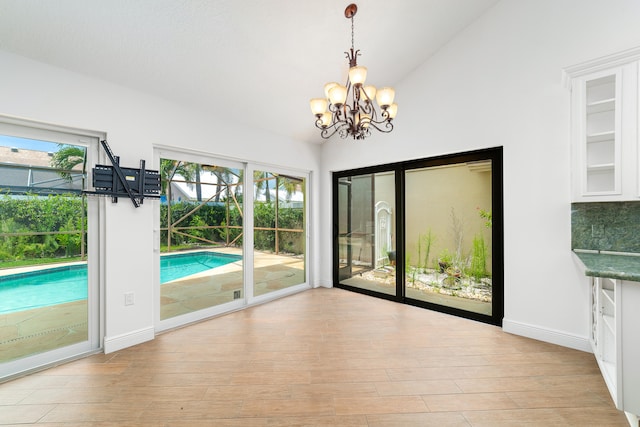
[405,160,492,316]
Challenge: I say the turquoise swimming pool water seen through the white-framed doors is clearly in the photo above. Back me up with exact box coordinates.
[0,252,242,314]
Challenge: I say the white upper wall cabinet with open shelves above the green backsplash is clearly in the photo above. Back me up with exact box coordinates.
[565,48,640,202]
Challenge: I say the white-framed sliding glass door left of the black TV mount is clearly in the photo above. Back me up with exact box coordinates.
[0,117,100,380]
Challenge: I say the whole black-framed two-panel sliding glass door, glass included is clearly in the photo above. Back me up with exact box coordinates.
[334,148,503,324]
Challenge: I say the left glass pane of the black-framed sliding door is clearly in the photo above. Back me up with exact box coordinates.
[338,172,396,295]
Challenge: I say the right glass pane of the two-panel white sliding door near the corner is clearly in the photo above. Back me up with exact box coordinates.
[253,171,306,296]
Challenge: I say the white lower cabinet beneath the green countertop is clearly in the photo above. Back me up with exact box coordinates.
[589,277,640,426]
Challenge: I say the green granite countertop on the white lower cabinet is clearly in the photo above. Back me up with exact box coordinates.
[573,250,640,282]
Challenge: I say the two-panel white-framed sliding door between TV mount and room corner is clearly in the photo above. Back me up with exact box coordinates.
[154,147,309,330]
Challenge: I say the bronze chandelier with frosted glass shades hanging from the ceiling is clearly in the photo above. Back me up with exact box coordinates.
[310,4,398,139]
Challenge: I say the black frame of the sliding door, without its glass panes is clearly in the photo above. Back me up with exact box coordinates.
[333,147,504,326]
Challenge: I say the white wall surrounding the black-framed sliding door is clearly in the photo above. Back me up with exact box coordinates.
[321,0,640,349]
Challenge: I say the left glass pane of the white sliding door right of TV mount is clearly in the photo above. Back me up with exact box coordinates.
[160,159,243,320]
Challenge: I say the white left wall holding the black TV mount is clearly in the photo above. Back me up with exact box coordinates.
[0,51,320,349]
